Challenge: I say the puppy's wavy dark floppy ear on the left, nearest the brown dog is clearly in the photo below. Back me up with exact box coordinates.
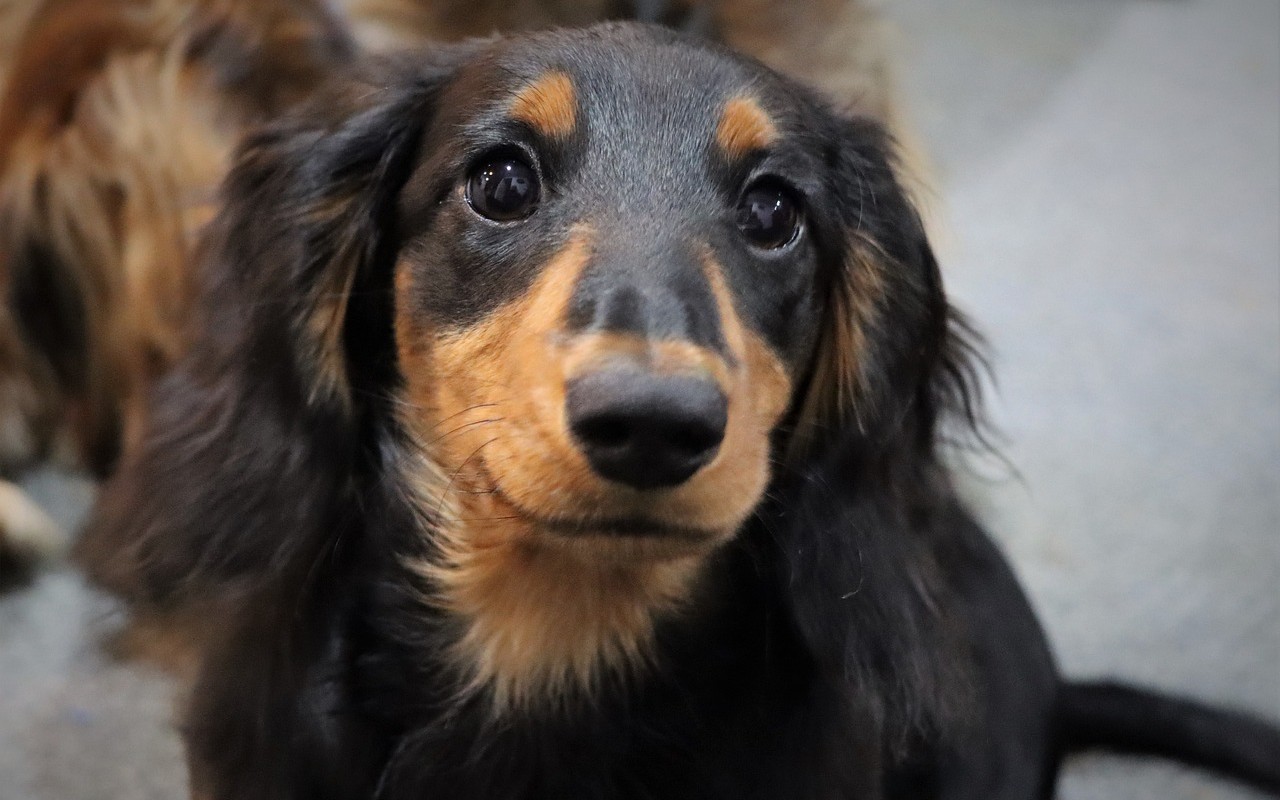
[73,51,465,603]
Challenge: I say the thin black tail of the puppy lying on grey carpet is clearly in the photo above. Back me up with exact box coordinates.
[1057,682,1280,796]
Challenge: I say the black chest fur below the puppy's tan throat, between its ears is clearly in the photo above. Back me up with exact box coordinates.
[302,494,879,800]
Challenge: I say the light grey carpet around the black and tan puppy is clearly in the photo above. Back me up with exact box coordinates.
[0,0,1280,800]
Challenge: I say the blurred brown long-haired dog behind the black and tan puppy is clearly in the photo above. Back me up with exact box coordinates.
[0,0,911,576]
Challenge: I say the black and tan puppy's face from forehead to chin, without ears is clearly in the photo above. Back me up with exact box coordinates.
[394,28,880,558]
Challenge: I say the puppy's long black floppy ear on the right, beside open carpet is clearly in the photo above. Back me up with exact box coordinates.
[764,110,975,756]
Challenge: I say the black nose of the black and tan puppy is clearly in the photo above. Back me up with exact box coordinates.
[564,367,728,489]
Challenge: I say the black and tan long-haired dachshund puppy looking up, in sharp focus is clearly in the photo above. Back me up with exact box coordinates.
[74,23,1280,800]
